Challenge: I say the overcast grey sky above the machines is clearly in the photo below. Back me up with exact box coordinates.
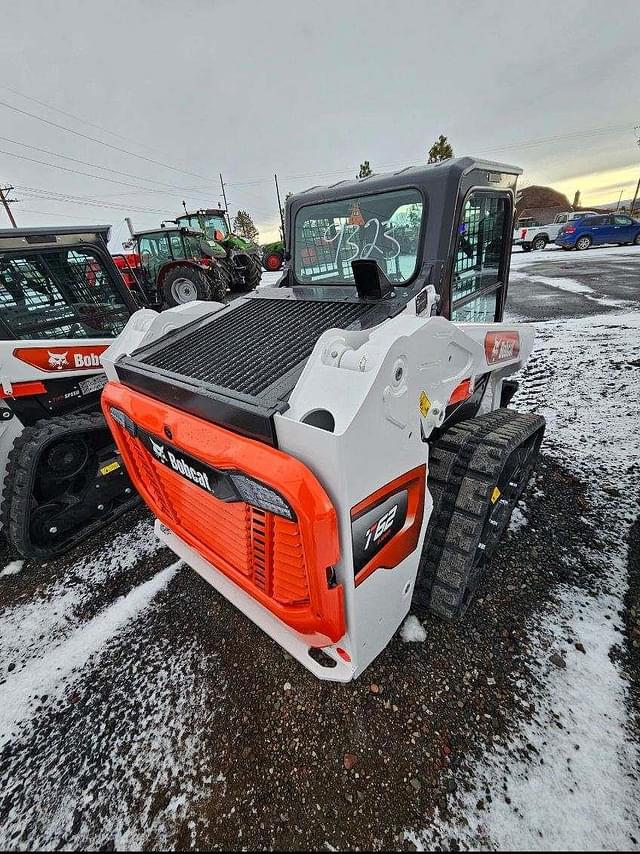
[0,0,640,248]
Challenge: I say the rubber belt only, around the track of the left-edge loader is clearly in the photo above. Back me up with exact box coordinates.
[0,412,140,558]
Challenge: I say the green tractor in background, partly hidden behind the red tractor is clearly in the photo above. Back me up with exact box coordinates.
[175,208,262,292]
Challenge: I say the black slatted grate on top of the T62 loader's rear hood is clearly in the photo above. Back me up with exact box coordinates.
[137,299,371,396]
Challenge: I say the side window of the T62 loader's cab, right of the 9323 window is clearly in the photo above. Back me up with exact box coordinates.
[451,190,511,323]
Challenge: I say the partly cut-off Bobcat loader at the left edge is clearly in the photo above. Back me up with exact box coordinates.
[0,225,137,559]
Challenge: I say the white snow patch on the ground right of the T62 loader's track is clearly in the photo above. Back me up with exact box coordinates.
[410,312,640,850]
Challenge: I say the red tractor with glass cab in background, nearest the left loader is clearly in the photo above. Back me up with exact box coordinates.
[126,226,227,308]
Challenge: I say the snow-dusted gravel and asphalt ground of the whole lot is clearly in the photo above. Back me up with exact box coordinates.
[0,247,640,850]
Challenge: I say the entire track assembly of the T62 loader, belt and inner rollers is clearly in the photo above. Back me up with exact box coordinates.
[413,409,545,620]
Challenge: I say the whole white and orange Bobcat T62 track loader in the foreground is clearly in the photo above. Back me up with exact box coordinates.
[102,158,544,681]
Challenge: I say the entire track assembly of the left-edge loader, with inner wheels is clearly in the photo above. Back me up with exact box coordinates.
[2,413,139,560]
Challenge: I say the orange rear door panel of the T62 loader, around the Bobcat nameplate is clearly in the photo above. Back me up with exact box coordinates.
[102,383,345,646]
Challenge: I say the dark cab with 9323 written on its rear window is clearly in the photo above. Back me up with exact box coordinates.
[279,158,521,323]
